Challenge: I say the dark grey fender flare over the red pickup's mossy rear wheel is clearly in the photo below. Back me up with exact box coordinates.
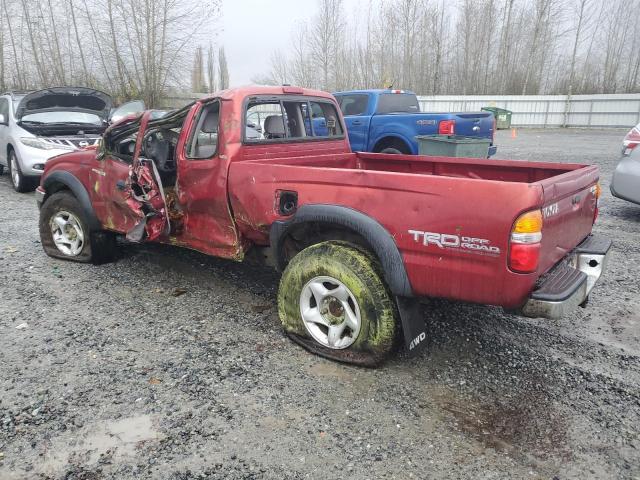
[269,204,413,297]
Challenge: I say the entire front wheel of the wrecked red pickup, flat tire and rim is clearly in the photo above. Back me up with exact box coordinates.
[40,191,115,263]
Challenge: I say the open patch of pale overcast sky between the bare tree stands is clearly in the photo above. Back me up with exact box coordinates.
[221,0,316,87]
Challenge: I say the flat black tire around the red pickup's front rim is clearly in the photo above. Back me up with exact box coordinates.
[39,191,116,264]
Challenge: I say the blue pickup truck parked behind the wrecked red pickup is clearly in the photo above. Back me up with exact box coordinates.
[333,90,496,157]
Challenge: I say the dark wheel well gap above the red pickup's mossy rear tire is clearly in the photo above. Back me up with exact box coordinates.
[281,222,380,265]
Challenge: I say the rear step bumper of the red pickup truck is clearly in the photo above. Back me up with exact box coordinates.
[520,235,611,319]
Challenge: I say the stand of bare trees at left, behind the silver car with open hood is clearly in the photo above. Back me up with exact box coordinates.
[0,0,220,103]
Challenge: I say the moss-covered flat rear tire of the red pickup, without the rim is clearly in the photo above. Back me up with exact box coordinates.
[278,241,399,367]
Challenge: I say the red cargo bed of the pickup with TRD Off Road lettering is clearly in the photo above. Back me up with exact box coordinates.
[229,152,598,308]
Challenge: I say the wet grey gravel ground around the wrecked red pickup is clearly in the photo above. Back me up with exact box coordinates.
[0,130,640,480]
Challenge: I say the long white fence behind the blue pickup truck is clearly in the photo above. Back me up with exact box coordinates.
[418,93,640,127]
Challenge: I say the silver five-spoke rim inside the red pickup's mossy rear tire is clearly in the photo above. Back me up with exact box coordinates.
[300,276,362,350]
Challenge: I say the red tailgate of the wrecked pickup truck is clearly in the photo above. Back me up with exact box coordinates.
[540,166,599,273]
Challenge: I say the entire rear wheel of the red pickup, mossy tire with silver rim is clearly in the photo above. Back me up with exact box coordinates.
[278,242,398,366]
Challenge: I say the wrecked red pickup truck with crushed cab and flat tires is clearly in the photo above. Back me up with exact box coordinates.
[36,86,611,365]
